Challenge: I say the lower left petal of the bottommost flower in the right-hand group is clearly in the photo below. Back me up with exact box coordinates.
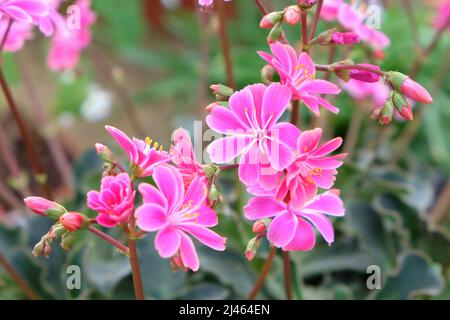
[267,211,298,248]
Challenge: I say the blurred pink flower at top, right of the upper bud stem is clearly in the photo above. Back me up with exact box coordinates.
[320,0,390,50]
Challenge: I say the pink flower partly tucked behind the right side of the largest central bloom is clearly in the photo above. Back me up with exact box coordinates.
[276,128,347,208]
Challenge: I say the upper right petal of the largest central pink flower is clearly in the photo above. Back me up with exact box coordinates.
[261,83,292,128]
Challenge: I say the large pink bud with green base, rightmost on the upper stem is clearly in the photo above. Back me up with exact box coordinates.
[387,71,433,104]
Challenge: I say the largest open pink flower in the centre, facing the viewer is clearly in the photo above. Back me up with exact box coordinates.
[206,83,300,185]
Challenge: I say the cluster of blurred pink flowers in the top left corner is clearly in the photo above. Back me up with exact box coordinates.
[0,0,96,71]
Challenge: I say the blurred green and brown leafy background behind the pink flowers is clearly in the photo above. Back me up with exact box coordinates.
[0,0,450,299]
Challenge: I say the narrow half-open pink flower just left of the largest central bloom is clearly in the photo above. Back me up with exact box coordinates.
[170,128,208,189]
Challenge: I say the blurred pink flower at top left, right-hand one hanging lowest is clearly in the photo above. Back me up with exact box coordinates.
[46,0,96,71]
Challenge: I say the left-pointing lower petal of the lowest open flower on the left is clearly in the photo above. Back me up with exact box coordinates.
[135,203,167,231]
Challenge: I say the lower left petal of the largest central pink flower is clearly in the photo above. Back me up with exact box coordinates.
[206,135,250,163]
